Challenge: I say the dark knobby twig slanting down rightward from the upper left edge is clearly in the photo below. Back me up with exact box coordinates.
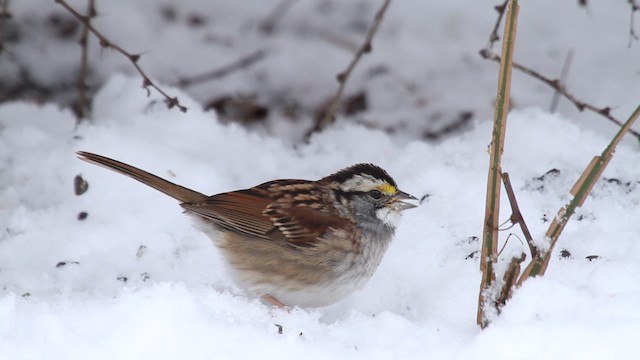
[54,0,187,112]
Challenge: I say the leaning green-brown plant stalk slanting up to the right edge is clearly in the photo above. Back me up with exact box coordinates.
[518,105,640,285]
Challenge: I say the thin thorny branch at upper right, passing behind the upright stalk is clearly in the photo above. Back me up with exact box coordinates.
[480,0,640,139]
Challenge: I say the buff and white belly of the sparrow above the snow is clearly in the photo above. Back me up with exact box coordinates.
[190,215,387,307]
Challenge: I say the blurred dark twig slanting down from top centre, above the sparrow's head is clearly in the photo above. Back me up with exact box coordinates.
[307,0,391,138]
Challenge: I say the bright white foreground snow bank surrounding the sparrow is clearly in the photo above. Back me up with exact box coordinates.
[0,76,640,359]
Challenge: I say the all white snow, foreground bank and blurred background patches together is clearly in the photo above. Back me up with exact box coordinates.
[0,0,640,359]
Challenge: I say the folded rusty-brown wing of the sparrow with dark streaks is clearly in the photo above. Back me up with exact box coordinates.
[181,180,343,246]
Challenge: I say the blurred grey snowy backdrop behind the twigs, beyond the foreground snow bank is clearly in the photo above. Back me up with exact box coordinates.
[0,0,640,144]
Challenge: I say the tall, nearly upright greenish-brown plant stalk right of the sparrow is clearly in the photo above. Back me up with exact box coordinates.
[477,0,518,327]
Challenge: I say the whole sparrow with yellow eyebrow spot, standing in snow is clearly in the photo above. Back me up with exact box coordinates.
[78,151,416,307]
